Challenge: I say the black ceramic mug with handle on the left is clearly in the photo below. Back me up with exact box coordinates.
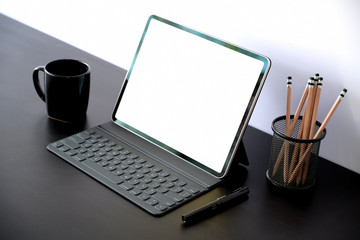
[33,59,90,122]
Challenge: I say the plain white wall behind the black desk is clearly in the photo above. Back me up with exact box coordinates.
[0,0,360,173]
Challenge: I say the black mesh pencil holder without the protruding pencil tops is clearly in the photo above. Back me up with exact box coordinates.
[266,115,326,189]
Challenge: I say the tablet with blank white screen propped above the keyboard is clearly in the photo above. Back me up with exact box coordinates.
[112,15,271,178]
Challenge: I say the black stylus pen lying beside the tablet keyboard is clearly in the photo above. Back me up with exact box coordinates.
[182,187,249,223]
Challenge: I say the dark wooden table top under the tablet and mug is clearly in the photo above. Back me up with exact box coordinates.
[0,15,360,240]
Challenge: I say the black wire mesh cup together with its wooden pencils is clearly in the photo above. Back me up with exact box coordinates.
[266,74,347,189]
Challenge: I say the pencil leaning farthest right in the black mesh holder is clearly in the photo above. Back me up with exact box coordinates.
[289,88,347,182]
